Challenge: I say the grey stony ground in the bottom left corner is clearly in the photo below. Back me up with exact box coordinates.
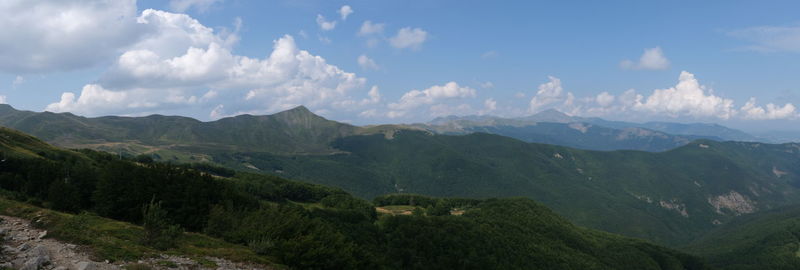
[0,215,272,270]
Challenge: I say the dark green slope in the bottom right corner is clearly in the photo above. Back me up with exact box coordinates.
[686,206,800,269]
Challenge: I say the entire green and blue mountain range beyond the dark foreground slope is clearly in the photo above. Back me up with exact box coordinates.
[0,105,800,249]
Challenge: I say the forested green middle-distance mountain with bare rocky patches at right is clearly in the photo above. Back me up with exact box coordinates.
[214,131,800,245]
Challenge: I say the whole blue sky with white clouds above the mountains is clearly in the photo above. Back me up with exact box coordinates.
[0,0,800,131]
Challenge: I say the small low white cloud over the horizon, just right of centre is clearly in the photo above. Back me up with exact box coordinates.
[387,82,476,118]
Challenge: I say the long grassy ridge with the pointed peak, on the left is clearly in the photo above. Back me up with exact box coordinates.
[0,104,359,155]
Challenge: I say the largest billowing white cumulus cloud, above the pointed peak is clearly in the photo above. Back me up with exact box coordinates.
[47,6,380,118]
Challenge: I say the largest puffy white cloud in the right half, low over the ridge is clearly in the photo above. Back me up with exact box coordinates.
[634,71,736,119]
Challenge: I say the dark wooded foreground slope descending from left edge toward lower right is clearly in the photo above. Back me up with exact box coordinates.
[0,128,705,269]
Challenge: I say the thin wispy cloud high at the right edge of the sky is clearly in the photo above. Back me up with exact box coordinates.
[728,26,800,53]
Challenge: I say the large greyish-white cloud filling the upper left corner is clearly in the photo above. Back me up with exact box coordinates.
[0,0,147,73]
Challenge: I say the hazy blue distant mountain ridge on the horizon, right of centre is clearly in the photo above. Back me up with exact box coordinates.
[422,109,762,152]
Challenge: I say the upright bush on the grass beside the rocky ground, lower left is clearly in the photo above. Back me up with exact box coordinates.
[142,200,182,250]
